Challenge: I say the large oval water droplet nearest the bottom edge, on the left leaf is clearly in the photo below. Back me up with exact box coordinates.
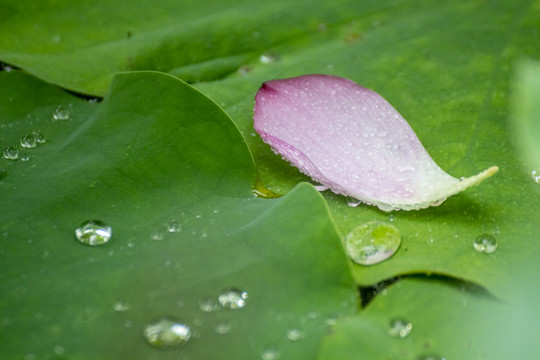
[143,317,191,349]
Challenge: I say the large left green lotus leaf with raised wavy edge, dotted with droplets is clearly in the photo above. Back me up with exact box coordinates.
[0,71,357,359]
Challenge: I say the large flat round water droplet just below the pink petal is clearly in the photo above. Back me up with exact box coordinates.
[345,221,401,265]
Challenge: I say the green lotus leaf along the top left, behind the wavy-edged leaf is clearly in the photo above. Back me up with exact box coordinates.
[0,0,376,95]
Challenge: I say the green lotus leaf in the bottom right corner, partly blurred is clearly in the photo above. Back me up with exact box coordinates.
[318,278,540,360]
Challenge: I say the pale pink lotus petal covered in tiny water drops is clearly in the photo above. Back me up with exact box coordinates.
[254,75,498,211]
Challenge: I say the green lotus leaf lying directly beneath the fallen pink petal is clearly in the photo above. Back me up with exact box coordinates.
[193,1,540,299]
